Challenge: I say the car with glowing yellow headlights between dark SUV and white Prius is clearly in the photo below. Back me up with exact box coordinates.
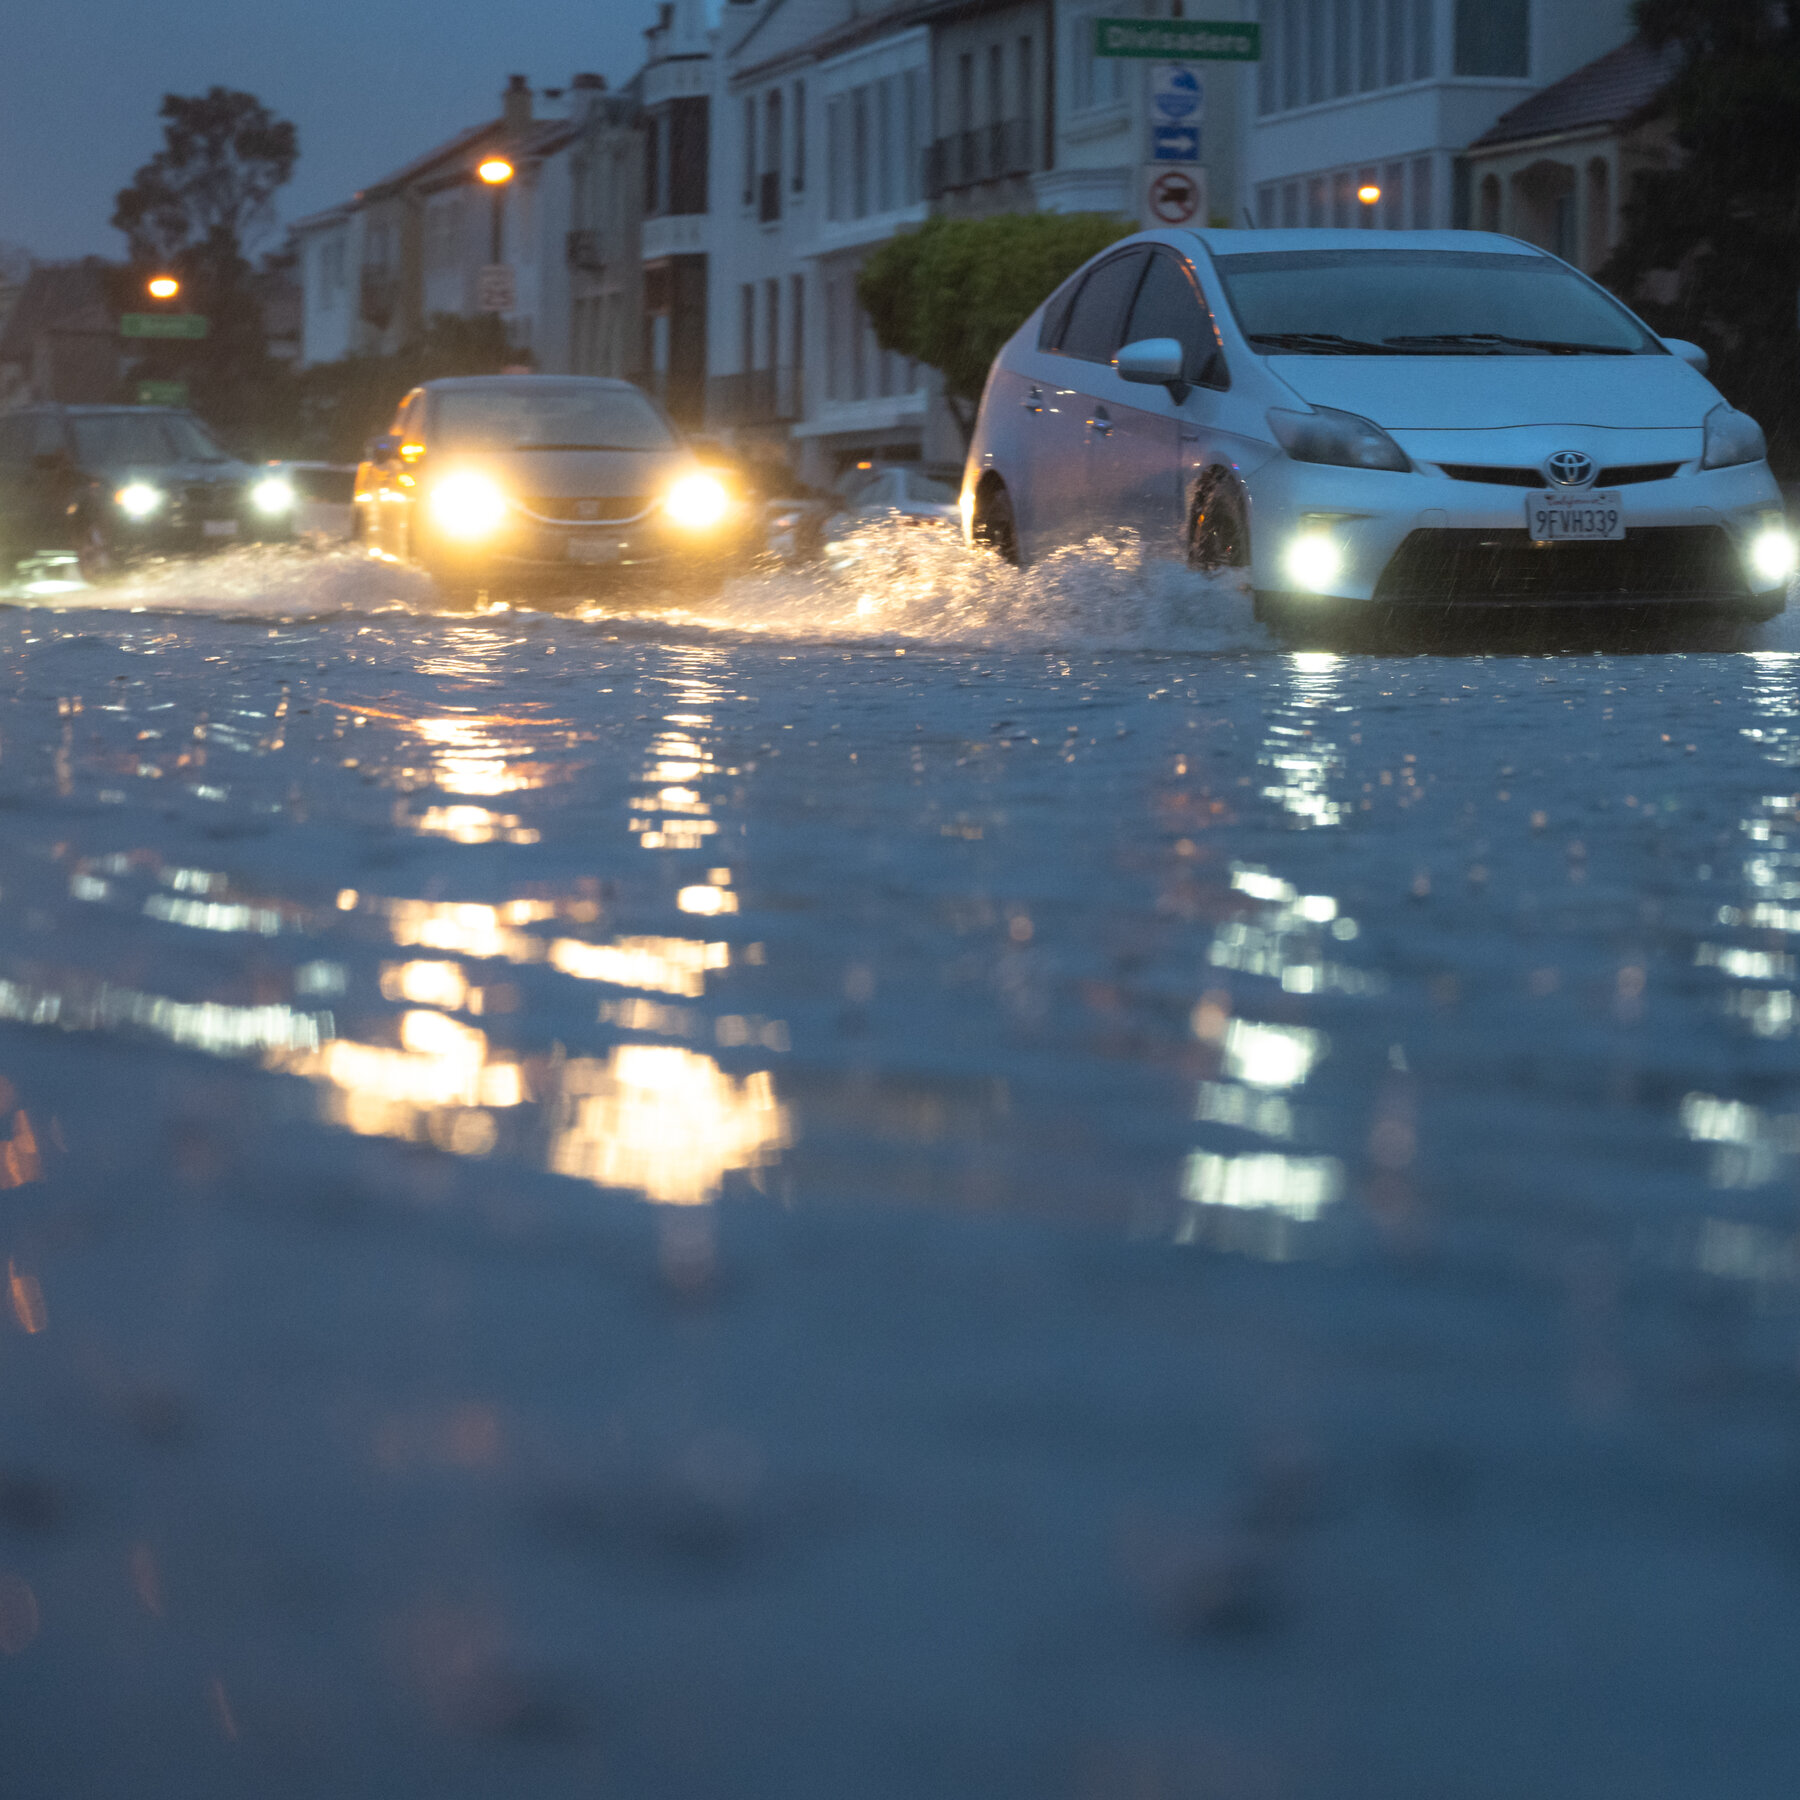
[353,374,761,601]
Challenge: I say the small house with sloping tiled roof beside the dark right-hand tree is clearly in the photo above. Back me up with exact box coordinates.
[1467,38,1679,275]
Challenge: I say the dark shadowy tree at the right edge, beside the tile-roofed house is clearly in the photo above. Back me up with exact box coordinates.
[1604,0,1800,473]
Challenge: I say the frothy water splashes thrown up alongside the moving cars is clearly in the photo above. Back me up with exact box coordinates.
[0,522,1271,652]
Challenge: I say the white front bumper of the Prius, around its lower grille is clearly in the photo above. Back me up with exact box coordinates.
[1249,457,1786,610]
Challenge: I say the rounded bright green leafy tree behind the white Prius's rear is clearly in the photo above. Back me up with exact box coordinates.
[857,212,1136,437]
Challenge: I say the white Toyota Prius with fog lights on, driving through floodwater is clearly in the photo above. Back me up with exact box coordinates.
[961,230,1795,619]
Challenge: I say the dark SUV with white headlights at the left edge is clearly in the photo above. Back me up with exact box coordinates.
[0,405,295,576]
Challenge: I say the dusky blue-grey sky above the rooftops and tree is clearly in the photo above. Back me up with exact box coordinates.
[0,0,655,257]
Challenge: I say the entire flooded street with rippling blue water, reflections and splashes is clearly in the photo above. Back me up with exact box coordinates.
[0,549,1800,1800]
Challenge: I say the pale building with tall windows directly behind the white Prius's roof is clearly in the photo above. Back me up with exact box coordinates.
[1246,0,1631,229]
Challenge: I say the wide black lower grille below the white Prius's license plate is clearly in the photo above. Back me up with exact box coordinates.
[1375,526,1750,607]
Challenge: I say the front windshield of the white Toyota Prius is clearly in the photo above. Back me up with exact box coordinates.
[1215,248,1667,356]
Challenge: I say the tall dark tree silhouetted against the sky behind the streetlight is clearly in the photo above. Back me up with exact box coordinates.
[112,88,299,436]
